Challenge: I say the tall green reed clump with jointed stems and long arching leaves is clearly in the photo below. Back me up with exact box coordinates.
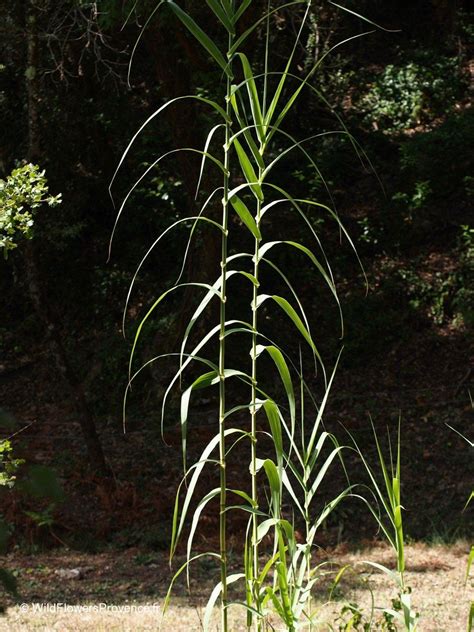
[114,0,392,631]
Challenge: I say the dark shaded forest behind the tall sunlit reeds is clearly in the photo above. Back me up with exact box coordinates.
[0,0,474,549]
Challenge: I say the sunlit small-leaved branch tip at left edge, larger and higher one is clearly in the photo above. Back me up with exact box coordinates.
[0,163,61,258]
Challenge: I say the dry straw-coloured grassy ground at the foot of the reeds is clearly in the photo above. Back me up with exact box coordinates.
[0,542,474,632]
